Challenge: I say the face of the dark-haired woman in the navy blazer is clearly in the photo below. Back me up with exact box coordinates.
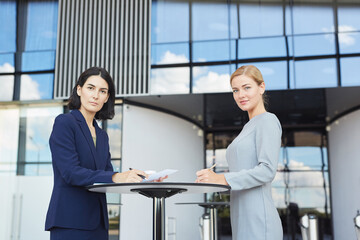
[77,75,109,114]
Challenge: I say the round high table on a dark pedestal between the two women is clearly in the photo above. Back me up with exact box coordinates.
[86,182,230,240]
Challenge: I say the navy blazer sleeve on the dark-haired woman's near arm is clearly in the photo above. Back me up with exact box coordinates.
[49,115,114,186]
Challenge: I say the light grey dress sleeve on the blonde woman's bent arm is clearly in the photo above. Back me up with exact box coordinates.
[224,116,281,190]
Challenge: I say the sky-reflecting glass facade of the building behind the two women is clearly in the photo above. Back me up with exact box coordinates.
[0,0,360,238]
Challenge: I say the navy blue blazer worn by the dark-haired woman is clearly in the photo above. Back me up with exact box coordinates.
[45,110,115,230]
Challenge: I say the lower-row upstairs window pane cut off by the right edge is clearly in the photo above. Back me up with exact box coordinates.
[340,57,360,86]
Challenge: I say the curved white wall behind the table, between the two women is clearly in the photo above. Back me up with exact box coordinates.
[120,105,204,240]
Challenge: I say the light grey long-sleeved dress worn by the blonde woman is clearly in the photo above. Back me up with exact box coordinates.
[225,112,283,240]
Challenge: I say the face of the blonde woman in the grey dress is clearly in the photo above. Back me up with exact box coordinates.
[231,75,265,113]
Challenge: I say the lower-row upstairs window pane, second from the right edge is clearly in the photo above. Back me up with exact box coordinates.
[290,59,337,88]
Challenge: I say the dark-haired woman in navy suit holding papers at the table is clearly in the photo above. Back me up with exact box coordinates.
[45,67,147,240]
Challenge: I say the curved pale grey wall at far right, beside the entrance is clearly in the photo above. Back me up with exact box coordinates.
[329,110,360,240]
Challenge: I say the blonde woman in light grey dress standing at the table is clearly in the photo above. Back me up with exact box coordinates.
[196,65,283,240]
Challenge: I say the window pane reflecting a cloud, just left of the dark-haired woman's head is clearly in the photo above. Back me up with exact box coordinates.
[20,73,54,100]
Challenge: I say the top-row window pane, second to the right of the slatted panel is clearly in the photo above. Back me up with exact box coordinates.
[191,2,229,41]
